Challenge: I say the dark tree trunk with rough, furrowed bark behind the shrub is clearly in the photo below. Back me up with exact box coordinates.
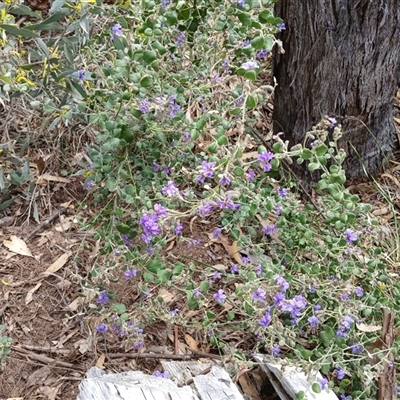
[273,0,400,182]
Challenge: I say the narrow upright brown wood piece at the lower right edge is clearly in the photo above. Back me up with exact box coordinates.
[379,309,397,400]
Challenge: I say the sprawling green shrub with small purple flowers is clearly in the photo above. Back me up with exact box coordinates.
[2,0,400,399]
